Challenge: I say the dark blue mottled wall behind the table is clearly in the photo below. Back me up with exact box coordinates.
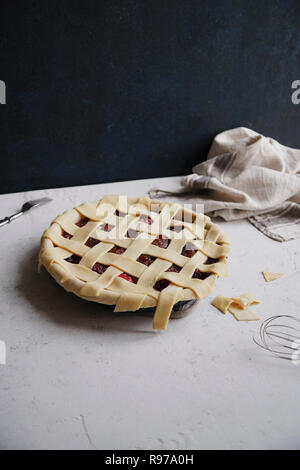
[0,0,300,193]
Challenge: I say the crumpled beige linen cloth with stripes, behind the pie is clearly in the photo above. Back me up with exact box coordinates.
[150,127,300,241]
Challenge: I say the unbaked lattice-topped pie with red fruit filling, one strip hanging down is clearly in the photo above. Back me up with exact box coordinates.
[39,195,230,329]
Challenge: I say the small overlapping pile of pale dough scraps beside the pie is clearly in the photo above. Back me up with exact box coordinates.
[212,294,260,321]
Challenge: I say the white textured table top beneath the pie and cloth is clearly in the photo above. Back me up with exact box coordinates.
[0,178,300,450]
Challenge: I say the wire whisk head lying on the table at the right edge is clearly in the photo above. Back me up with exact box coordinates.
[253,315,300,364]
